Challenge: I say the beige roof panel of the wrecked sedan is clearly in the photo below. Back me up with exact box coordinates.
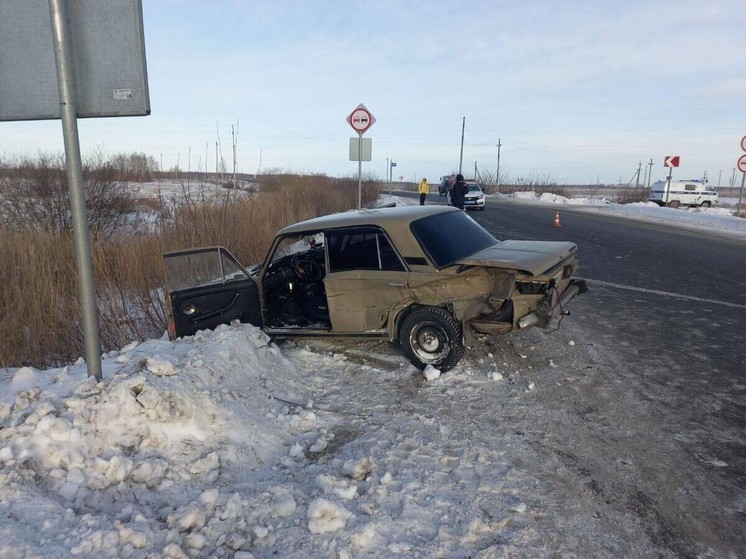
[278,205,461,235]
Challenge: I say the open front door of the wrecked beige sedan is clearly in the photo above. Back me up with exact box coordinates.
[163,247,262,340]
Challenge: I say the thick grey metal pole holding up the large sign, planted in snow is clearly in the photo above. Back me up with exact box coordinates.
[49,0,101,380]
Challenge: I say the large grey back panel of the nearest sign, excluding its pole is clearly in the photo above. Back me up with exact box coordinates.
[0,0,150,121]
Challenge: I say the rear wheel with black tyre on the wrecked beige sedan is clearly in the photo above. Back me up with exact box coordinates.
[399,307,464,371]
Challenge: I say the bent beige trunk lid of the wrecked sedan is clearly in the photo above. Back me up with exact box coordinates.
[456,241,578,276]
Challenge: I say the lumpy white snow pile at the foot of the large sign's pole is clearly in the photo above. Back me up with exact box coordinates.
[0,326,330,559]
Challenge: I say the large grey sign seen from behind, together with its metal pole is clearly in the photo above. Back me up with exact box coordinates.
[0,0,150,379]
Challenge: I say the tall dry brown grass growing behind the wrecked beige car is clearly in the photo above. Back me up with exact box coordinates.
[0,166,378,367]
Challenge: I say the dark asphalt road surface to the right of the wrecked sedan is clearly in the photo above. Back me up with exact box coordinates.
[406,191,746,557]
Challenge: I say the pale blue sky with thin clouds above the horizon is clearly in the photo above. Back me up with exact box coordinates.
[0,0,746,185]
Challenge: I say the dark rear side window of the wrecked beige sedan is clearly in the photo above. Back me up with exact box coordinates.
[326,227,405,272]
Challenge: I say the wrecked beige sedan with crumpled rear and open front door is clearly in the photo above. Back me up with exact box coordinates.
[164,206,586,371]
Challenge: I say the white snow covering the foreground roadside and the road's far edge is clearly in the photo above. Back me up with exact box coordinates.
[0,190,746,559]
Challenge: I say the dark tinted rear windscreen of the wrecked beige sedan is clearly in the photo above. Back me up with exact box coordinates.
[410,212,498,268]
